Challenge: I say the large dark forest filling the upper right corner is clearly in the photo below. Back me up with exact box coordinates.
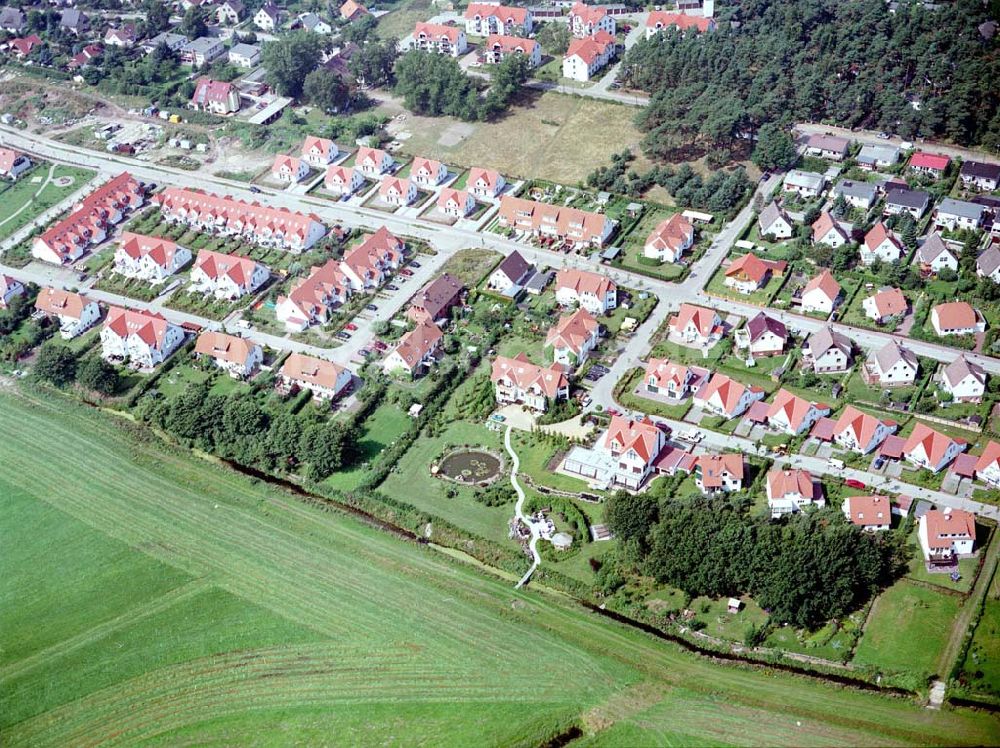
[623,0,1000,158]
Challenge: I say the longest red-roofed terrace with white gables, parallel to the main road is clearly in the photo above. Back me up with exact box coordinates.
[155,187,326,253]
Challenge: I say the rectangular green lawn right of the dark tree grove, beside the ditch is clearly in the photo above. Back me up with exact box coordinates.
[854,579,960,679]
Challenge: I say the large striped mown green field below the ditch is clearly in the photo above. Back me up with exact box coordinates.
[0,391,996,745]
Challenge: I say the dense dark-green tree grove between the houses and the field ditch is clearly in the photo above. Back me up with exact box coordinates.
[605,492,906,627]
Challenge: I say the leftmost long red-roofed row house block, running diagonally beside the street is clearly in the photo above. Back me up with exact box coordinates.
[31,172,146,265]
